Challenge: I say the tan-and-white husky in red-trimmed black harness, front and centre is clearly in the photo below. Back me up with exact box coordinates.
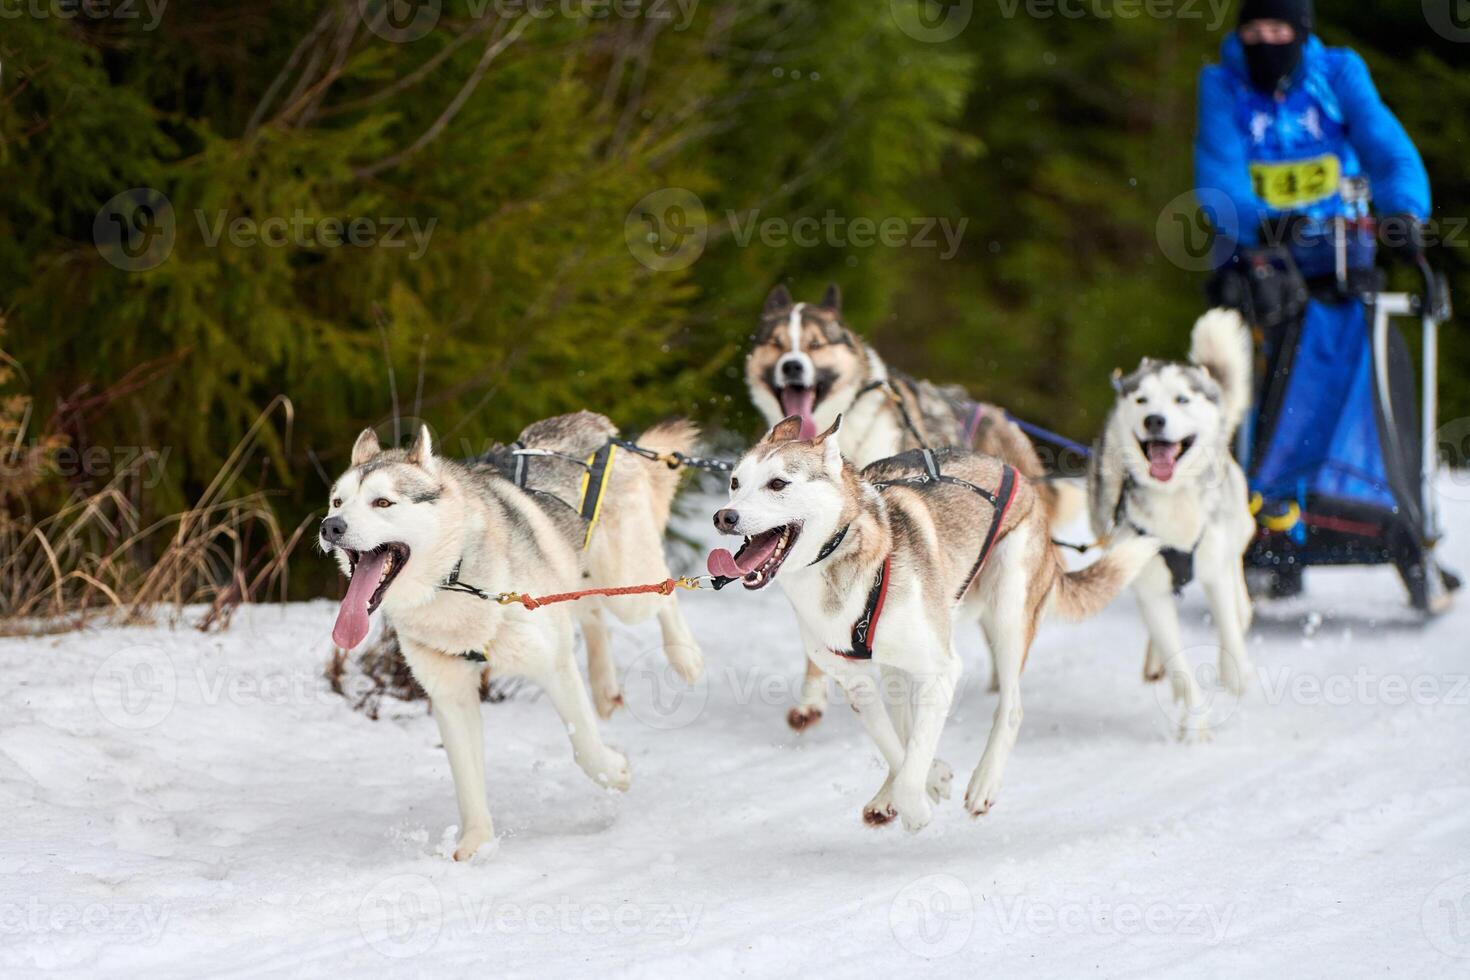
[710,416,1157,830]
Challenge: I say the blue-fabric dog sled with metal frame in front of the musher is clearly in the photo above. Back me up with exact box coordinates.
[1238,210,1460,616]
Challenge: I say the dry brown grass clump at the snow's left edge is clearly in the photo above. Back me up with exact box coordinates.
[0,397,307,635]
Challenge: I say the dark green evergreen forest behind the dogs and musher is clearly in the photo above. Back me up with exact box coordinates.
[0,0,1470,594]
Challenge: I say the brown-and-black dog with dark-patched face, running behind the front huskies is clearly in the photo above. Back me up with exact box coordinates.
[745,284,1082,732]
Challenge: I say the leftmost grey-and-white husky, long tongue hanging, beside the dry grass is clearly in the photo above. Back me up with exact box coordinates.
[320,413,700,860]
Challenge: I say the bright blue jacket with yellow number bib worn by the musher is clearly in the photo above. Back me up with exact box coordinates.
[1195,32,1429,247]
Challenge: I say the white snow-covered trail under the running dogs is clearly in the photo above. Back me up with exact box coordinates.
[0,480,1470,979]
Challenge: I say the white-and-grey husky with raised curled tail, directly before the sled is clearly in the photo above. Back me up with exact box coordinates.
[1088,310,1255,736]
